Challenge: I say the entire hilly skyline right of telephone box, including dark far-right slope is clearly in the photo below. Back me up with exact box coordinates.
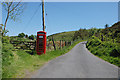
[47,22,120,43]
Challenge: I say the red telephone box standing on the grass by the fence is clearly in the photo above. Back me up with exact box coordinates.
[36,31,46,55]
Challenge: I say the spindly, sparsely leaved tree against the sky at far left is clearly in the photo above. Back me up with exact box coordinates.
[2,0,24,34]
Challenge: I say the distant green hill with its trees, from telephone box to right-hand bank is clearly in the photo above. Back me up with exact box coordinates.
[47,28,101,41]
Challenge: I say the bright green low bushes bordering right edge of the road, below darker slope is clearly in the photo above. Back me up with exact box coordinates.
[87,37,120,67]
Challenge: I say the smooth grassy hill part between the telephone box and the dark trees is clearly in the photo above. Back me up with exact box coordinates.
[47,31,75,41]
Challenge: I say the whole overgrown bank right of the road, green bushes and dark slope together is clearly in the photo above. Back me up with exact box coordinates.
[87,22,120,67]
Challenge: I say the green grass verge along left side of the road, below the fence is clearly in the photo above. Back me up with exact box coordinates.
[2,41,84,78]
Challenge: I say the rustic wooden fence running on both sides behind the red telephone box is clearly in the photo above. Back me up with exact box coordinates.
[10,40,72,51]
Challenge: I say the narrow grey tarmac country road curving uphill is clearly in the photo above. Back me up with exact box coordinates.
[31,42,118,78]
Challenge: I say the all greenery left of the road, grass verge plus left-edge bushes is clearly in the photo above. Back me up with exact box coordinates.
[2,33,84,78]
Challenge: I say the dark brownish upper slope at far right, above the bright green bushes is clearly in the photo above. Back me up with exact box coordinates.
[95,22,120,43]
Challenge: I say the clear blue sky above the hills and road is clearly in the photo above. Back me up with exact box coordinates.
[2,2,118,36]
